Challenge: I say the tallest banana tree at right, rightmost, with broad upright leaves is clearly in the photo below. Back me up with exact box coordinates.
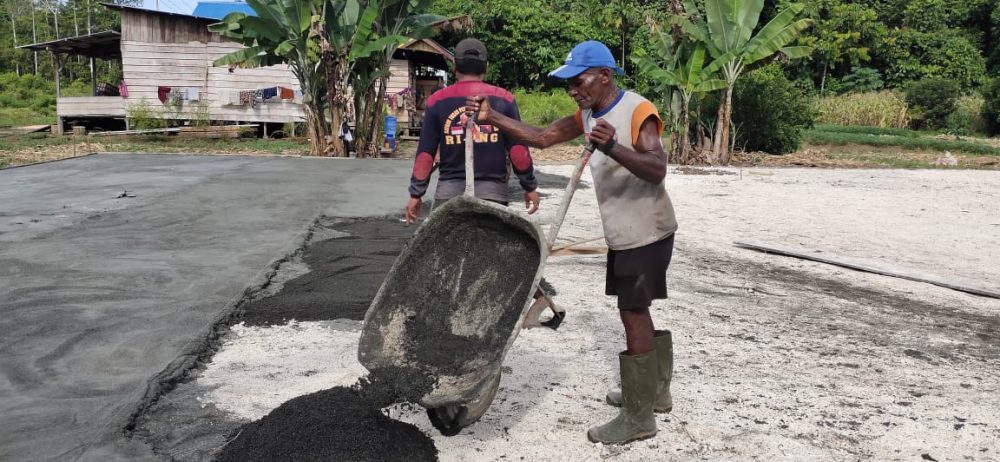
[682,0,812,164]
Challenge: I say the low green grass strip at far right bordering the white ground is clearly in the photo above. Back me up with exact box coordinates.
[805,126,1000,156]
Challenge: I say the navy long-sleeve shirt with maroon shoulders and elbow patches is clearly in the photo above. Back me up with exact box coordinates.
[410,80,538,197]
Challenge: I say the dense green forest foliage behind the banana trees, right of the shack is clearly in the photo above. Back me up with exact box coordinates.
[430,0,1000,94]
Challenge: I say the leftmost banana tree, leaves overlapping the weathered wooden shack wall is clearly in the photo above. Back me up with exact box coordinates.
[208,0,327,155]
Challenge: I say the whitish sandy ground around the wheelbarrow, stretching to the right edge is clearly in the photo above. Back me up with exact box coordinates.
[186,165,1000,461]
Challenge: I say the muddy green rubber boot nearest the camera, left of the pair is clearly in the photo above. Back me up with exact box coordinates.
[587,350,657,444]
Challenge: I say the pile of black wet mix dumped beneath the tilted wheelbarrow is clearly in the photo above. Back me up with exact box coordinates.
[218,369,437,462]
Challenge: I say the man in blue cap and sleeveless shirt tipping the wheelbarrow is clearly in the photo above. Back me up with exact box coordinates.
[466,41,677,443]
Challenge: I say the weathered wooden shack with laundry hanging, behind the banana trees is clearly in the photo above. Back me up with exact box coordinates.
[21,4,454,132]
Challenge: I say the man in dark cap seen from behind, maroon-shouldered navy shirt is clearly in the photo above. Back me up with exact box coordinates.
[406,38,538,224]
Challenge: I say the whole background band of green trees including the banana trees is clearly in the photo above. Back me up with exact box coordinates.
[0,0,1000,163]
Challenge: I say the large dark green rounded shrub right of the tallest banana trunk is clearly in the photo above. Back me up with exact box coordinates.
[733,64,816,154]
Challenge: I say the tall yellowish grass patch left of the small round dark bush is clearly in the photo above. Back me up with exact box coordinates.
[814,90,910,128]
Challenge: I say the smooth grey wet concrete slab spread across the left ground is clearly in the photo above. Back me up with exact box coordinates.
[0,155,410,460]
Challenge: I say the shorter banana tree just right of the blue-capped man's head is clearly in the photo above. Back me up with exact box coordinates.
[633,27,726,164]
